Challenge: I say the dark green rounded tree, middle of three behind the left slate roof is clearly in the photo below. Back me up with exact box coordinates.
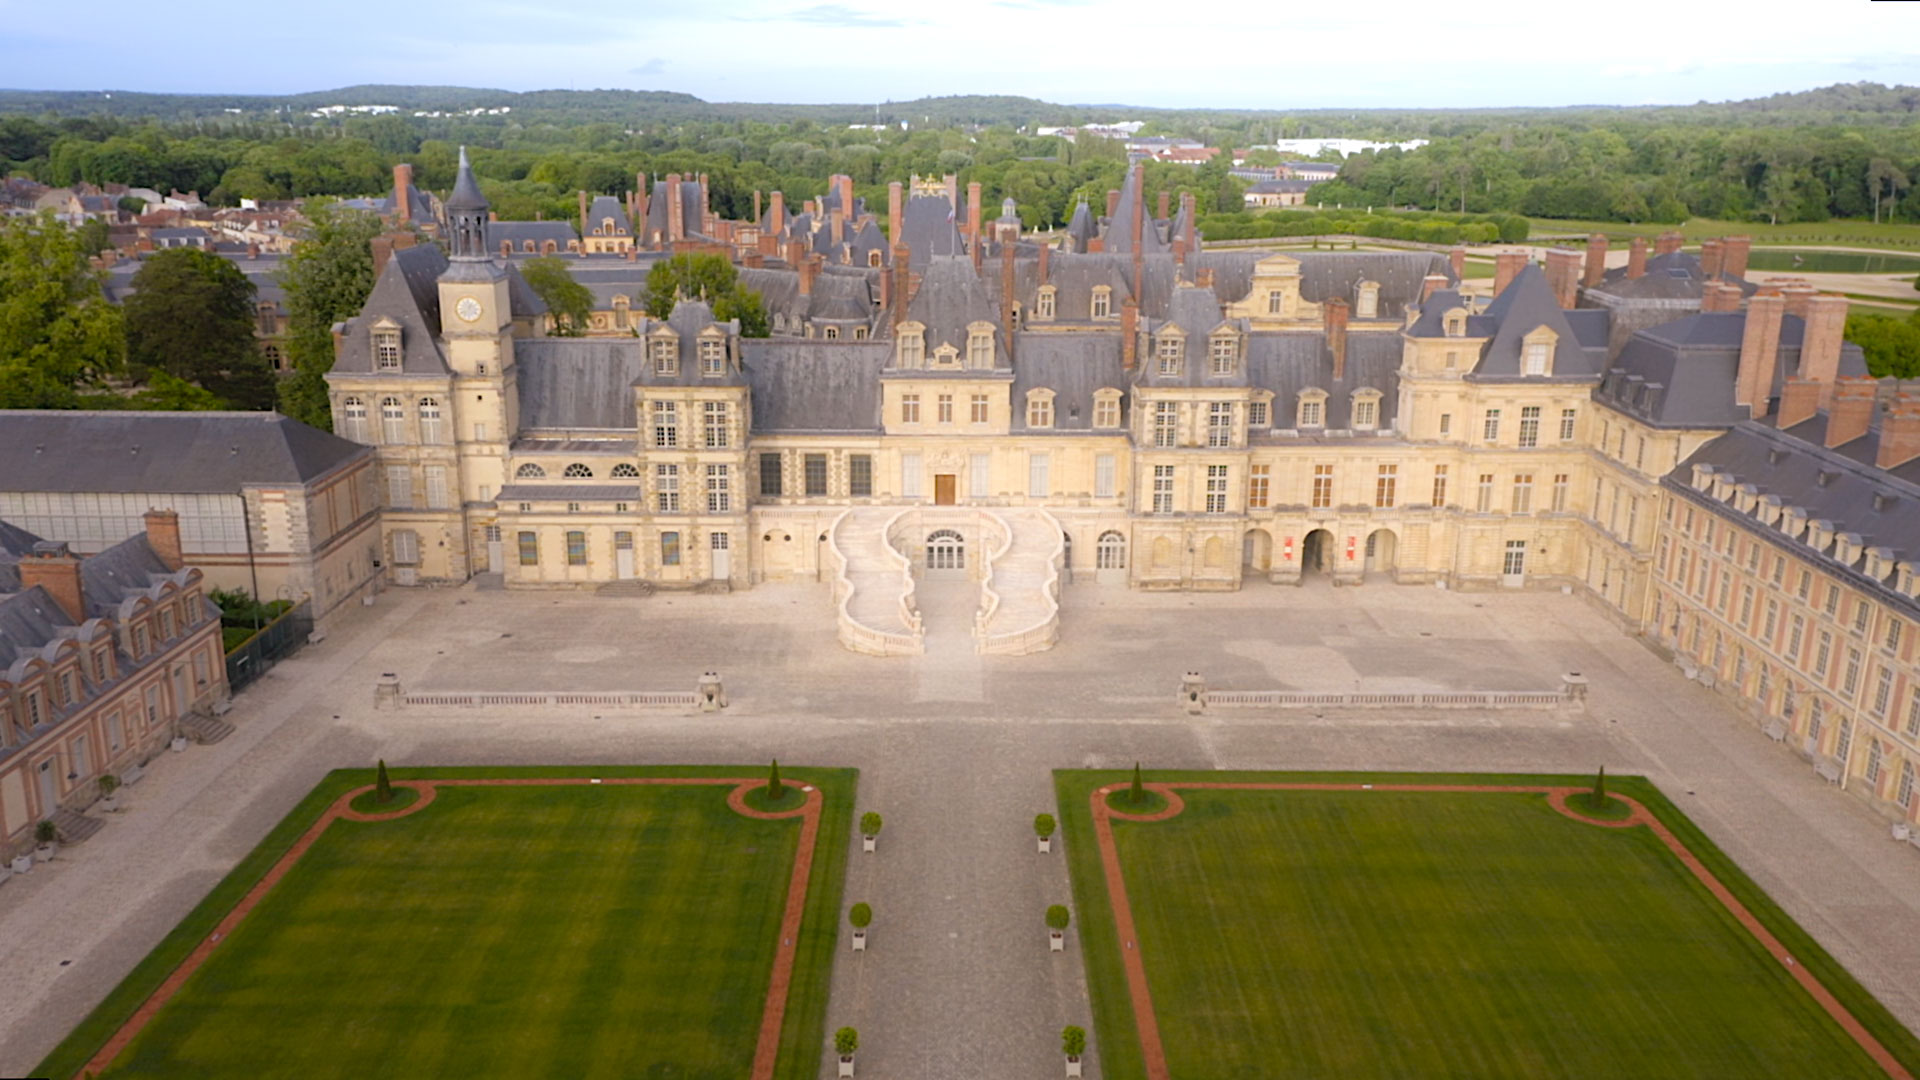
[123,248,275,409]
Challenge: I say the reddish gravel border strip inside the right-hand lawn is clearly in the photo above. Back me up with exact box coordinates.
[1089,780,1914,1080]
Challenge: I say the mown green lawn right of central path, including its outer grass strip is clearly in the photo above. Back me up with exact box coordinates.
[1056,773,1920,1080]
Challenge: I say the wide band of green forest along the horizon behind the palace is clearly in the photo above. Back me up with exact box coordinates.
[0,83,1920,227]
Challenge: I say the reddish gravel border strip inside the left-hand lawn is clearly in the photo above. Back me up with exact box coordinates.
[75,776,822,1080]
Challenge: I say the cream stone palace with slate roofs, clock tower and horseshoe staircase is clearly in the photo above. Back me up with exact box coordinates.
[328,151,1920,819]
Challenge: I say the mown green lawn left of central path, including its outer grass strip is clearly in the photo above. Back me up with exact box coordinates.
[40,769,854,1080]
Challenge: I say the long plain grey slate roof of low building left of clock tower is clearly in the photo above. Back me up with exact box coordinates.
[0,409,372,494]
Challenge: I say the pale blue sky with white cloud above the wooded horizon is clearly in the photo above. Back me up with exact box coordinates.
[0,0,1920,110]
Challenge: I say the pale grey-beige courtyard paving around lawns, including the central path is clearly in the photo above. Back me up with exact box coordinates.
[0,584,1920,1078]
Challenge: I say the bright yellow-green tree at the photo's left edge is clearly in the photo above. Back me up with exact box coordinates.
[0,213,127,409]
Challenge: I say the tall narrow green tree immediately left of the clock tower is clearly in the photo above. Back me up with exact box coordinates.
[280,204,380,430]
